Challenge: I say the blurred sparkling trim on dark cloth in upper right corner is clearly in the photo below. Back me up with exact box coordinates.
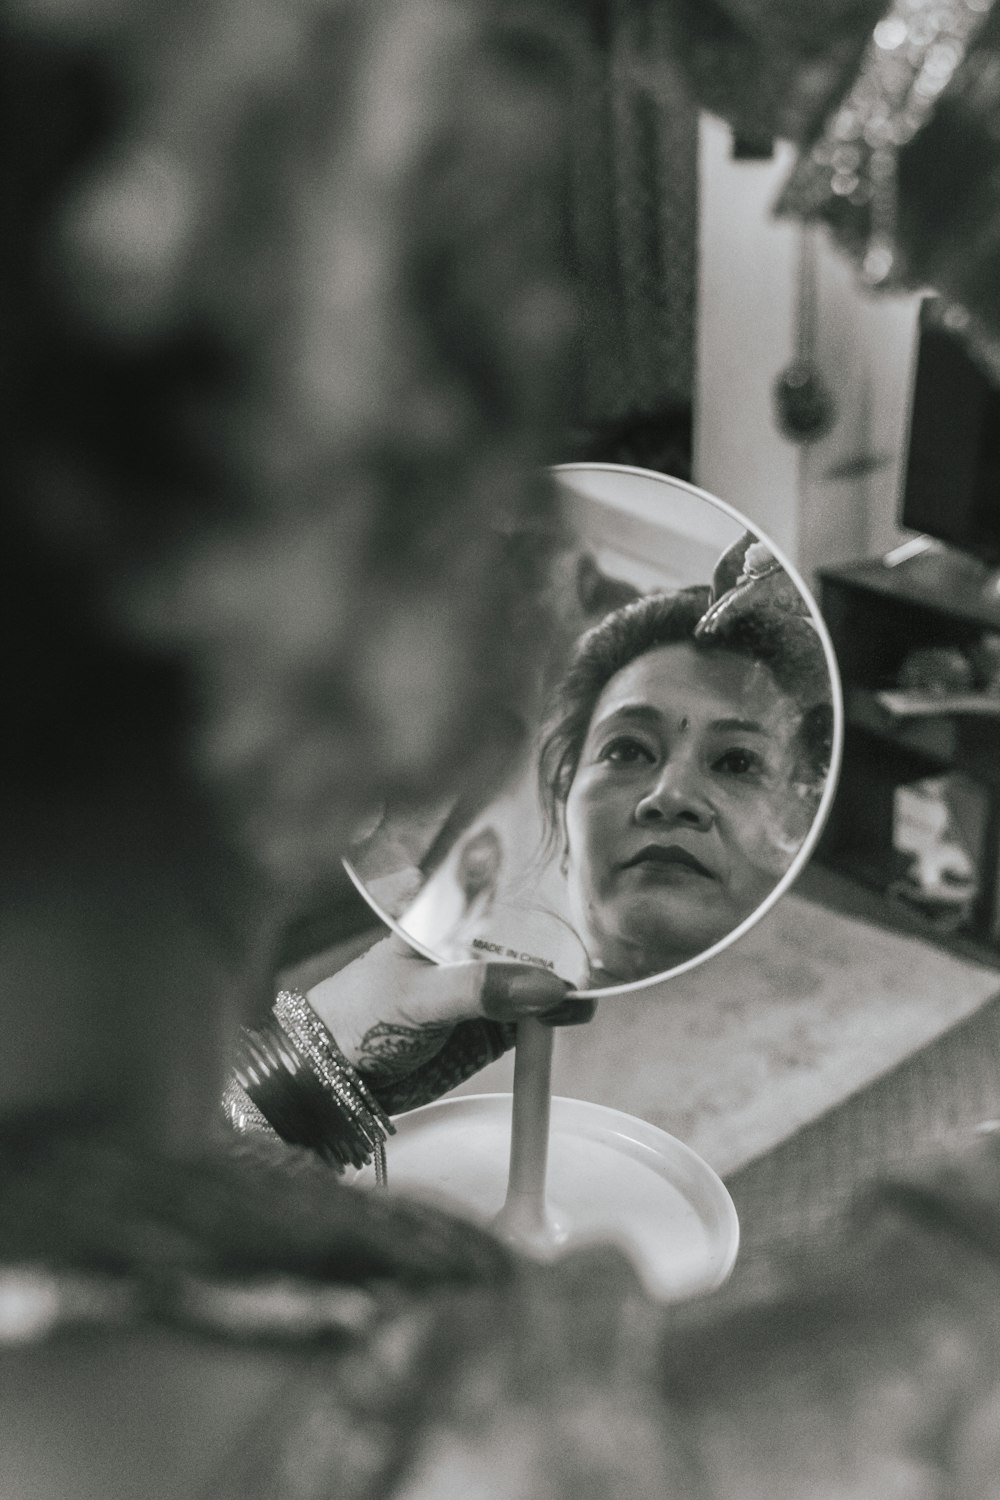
[777,0,993,287]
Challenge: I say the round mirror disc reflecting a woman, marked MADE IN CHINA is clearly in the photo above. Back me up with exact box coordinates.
[345,464,843,996]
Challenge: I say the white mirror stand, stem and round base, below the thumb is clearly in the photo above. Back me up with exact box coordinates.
[363,1020,739,1302]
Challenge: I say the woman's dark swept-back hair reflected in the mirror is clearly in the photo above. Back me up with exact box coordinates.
[538,587,834,842]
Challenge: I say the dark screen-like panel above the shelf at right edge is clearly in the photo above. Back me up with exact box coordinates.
[900,299,1000,564]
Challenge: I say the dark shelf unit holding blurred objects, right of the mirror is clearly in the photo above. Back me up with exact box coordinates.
[819,554,1000,953]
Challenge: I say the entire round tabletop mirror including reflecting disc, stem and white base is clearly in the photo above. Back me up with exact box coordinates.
[348,464,843,1301]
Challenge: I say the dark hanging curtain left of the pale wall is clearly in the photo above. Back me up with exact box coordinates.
[571,0,699,473]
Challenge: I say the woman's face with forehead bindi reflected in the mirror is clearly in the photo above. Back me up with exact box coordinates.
[565,642,814,984]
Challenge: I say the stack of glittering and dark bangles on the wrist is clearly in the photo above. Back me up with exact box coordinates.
[222,990,394,1184]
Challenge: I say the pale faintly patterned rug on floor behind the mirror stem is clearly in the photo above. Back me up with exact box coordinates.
[459,876,1000,1191]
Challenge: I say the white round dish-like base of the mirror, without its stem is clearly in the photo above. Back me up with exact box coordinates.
[357,1094,739,1301]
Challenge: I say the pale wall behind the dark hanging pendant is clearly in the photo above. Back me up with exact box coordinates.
[694,116,918,578]
